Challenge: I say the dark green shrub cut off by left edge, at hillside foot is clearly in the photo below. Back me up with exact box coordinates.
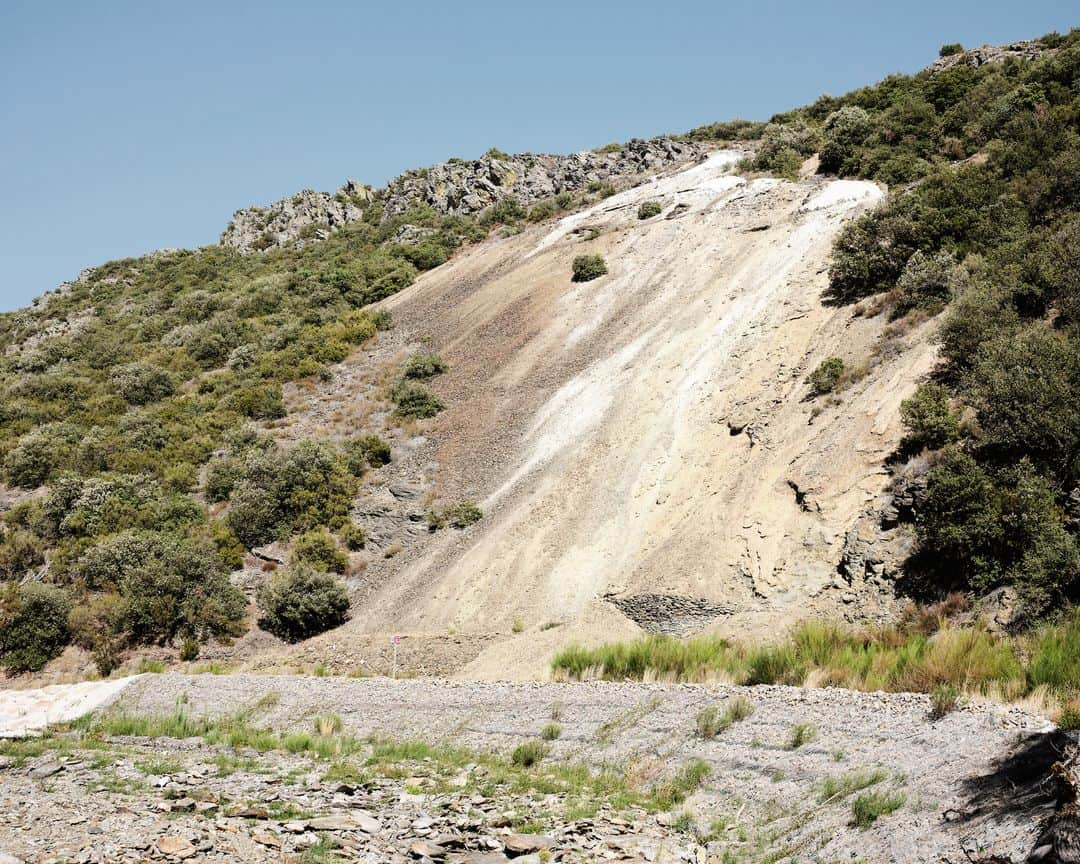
[0,582,71,673]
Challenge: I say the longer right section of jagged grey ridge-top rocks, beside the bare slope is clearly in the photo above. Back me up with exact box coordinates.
[384,138,703,217]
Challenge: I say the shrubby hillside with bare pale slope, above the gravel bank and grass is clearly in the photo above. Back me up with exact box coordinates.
[0,27,1080,704]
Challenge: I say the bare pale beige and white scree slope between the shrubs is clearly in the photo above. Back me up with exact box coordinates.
[278,151,934,677]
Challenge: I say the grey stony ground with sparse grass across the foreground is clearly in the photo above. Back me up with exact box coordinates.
[0,675,1068,864]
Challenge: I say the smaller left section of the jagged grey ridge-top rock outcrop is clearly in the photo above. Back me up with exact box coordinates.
[221,180,374,253]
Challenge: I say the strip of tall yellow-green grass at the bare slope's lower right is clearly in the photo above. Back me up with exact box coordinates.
[552,610,1080,702]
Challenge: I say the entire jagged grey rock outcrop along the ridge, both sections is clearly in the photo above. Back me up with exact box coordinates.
[220,138,704,254]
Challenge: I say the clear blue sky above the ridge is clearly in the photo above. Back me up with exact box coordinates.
[0,0,1080,310]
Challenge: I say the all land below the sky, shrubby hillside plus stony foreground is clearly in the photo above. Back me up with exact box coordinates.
[0,30,1080,864]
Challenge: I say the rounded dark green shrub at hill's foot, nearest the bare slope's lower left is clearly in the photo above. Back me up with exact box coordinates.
[258,567,349,642]
